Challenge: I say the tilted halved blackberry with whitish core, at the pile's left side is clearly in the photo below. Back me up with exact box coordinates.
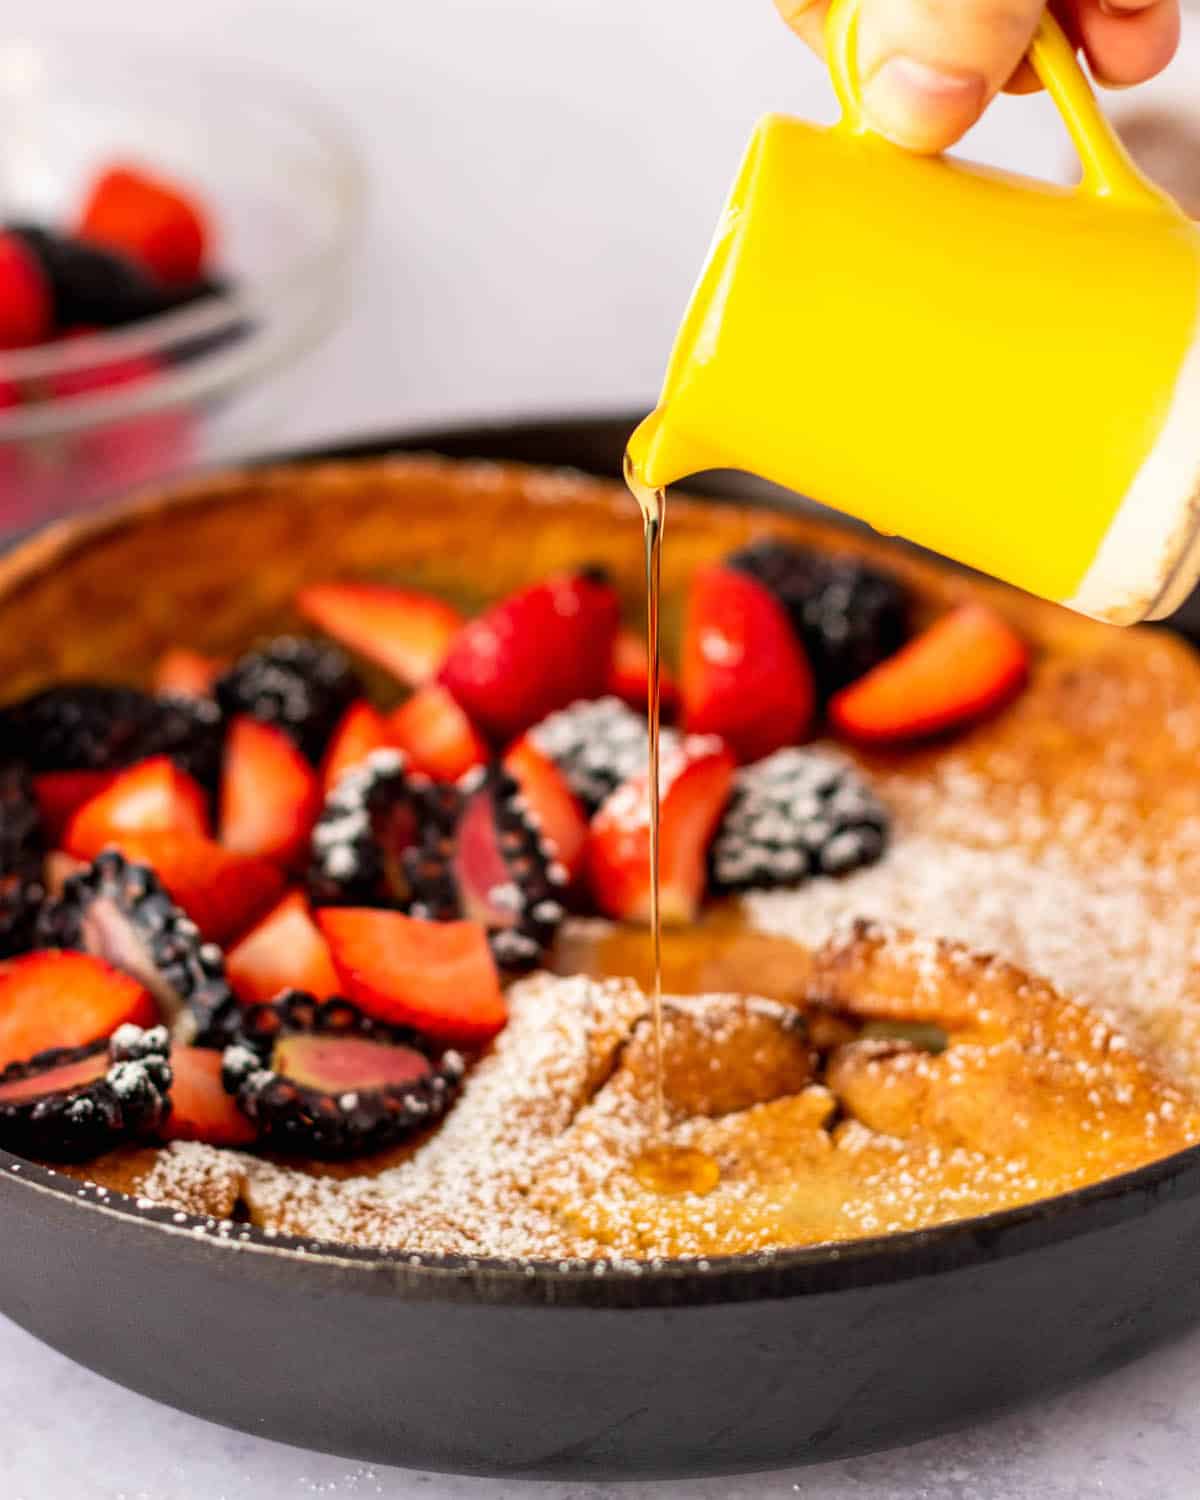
[36,849,237,1046]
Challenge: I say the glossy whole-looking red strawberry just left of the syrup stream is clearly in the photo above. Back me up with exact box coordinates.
[438,572,620,743]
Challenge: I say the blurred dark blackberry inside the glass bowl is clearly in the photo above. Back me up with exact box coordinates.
[9,224,171,330]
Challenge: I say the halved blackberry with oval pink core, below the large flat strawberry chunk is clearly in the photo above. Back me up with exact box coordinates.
[222,990,467,1157]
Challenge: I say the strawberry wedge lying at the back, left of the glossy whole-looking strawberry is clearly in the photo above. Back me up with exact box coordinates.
[296,584,462,687]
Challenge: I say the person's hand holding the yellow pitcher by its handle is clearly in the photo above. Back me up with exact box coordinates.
[776,0,1179,152]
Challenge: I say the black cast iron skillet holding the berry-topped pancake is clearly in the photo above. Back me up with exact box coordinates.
[0,419,1200,1479]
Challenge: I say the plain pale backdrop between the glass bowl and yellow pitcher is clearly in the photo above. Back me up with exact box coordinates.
[18,0,1086,437]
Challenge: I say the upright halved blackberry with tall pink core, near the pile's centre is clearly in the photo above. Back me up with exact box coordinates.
[404,767,567,969]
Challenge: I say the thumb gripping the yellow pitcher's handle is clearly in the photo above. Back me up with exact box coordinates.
[858,0,1044,152]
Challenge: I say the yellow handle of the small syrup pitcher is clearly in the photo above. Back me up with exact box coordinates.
[825,0,1179,213]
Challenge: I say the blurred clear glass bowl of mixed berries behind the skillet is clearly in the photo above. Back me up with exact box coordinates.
[0,38,362,536]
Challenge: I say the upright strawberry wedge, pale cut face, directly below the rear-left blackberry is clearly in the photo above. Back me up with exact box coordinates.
[221,714,321,864]
